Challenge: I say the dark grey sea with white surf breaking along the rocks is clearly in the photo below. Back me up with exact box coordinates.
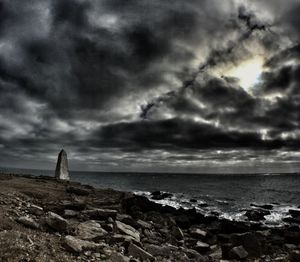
[0,168,300,226]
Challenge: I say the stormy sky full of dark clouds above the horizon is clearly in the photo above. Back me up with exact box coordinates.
[0,0,300,173]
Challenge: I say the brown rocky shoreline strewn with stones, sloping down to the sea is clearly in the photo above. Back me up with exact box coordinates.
[0,174,300,262]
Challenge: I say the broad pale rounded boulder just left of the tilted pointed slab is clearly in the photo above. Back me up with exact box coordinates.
[77,220,108,240]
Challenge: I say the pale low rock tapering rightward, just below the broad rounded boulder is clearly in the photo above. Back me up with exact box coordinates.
[65,236,106,253]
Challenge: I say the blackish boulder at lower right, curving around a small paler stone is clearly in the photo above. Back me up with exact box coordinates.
[231,232,261,257]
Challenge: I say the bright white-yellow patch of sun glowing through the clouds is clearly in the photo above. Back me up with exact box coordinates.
[224,57,263,90]
